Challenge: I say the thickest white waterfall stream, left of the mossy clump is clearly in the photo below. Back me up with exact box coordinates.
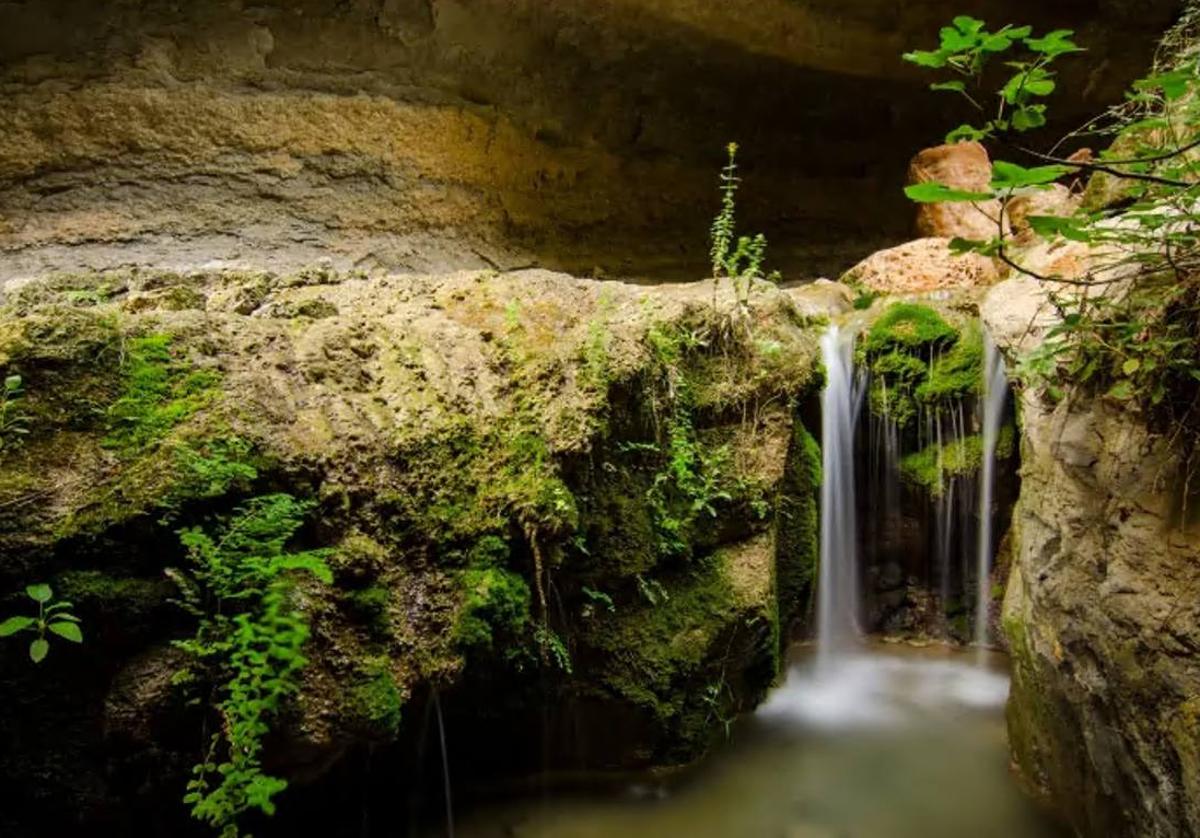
[817,325,864,665]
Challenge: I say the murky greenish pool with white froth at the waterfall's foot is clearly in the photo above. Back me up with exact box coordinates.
[446,647,1063,838]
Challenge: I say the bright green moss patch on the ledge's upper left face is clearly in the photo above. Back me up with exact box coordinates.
[104,333,221,455]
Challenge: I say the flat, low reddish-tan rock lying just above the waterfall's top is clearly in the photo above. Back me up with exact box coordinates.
[842,238,998,294]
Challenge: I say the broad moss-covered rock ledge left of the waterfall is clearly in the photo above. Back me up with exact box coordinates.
[0,271,835,832]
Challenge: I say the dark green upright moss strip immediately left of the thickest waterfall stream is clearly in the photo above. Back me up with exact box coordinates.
[775,419,822,641]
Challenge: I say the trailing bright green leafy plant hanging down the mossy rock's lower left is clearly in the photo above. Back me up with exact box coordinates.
[168,495,332,838]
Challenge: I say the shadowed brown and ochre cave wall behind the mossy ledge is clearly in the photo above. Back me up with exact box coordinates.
[0,0,1175,281]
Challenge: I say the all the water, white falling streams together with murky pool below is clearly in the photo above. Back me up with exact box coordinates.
[432,327,1041,838]
